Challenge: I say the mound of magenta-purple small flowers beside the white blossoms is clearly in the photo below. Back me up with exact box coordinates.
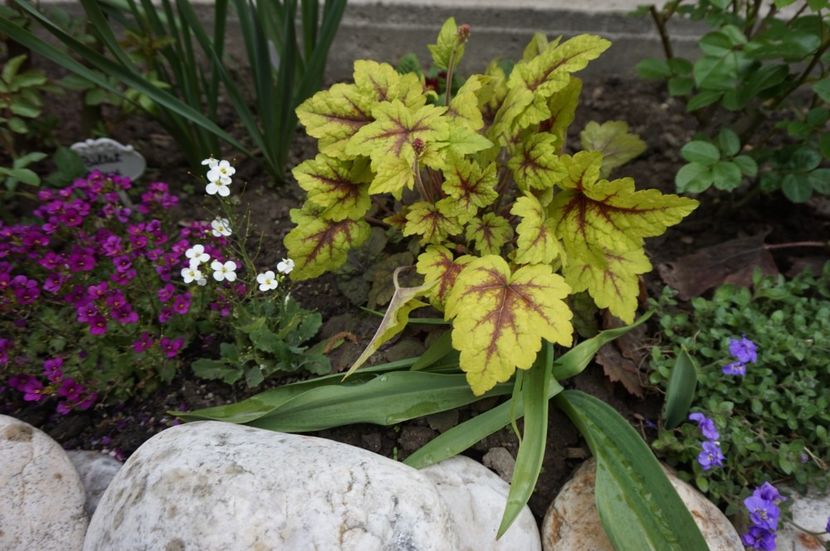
[0,171,227,413]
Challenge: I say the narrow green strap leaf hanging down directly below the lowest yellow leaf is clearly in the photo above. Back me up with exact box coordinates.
[496,342,555,538]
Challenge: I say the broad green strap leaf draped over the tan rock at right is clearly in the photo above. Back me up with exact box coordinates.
[555,390,708,551]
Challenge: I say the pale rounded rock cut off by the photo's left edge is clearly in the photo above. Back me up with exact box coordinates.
[0,415,87,551]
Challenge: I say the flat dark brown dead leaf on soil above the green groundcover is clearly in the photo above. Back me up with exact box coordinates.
[657,232,779,300]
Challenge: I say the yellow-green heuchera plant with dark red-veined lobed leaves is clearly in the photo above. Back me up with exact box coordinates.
[285,20,697,394]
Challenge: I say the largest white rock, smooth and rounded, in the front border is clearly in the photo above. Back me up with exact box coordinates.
[84,422,457,551]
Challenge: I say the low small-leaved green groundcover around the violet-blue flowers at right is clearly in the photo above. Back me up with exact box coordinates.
[651,264,830,514]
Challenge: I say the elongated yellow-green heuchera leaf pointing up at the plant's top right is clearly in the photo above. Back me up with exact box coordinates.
[493,34,611,138]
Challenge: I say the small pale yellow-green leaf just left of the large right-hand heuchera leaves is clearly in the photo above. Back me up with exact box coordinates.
[510,195,562,264]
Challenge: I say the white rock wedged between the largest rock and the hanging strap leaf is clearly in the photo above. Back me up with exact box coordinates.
[421,456,542,551]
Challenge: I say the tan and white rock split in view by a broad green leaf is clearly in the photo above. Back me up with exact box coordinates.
[542,459,744,551]
